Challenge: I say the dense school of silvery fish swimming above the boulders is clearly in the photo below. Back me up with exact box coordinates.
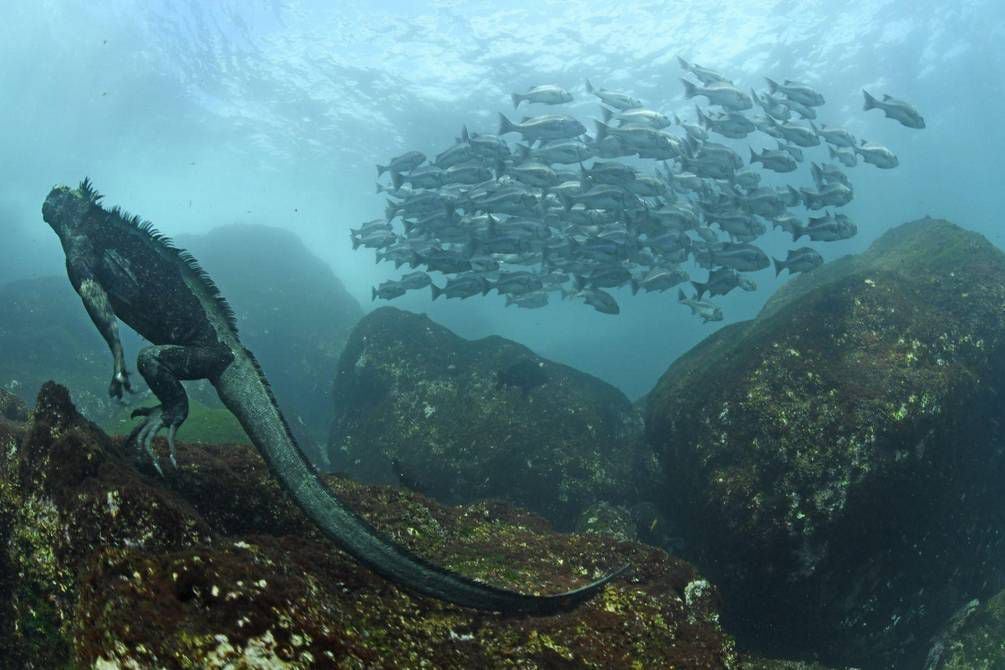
[351,58,925,322]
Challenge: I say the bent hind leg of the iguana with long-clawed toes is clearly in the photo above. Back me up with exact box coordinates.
[128,345,233,477]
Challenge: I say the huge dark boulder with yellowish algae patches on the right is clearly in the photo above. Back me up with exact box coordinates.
[647,219,1005,668]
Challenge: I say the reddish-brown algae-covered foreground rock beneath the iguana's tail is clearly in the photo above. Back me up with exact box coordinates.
[0,384,737,669]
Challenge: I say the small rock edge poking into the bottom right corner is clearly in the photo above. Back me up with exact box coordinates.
[925,591,1005,670]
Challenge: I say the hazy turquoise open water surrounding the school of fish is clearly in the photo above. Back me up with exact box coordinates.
[0,0,1005,396]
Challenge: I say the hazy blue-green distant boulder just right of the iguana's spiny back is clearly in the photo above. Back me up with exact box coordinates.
[176,224,363,460]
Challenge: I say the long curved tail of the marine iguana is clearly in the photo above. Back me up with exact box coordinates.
[214,352,627,615]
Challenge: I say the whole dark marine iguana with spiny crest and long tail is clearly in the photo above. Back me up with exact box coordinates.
[42,179,625,615]
